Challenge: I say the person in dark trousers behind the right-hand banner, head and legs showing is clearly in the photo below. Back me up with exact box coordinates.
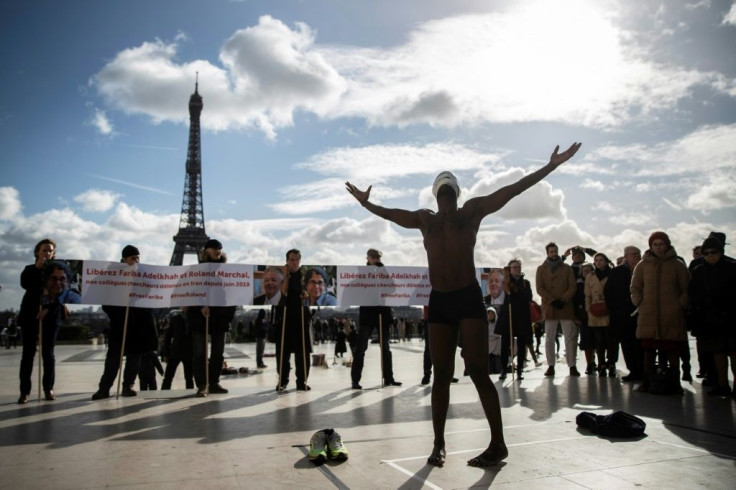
[350,248,401,390]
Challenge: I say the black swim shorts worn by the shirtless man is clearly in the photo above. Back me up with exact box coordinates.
[427,282,488,325]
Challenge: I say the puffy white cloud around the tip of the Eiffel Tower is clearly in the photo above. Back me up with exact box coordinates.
[90,15,344,138]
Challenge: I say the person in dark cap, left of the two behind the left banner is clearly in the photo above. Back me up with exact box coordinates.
[92,245,158,400]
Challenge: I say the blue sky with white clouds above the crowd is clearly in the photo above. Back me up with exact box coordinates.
[0,0,736,309]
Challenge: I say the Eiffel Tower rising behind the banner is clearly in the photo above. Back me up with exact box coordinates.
[169,75,209,265]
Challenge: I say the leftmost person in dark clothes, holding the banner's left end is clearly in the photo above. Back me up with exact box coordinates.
[18,238,56,403]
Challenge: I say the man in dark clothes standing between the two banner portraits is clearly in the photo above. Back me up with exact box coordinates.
[275,249,312,392]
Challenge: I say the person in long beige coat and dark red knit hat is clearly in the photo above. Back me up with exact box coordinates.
[631,231,690,392]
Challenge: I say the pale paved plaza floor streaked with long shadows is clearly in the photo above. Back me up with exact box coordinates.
[0,340,736,490]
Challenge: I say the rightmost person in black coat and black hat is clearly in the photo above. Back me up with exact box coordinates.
[688,236,736,396]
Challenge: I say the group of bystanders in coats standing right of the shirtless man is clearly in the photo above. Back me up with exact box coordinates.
[485,231,736,404]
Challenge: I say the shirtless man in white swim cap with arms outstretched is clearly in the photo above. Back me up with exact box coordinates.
[345,143,581,467]
